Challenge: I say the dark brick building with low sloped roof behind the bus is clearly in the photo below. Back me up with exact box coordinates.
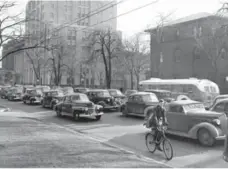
[146,13,228,92]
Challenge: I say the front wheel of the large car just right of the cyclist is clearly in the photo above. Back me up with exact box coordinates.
[197,128,215,147]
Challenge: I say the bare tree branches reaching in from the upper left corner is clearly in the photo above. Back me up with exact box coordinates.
[0,1,50,61]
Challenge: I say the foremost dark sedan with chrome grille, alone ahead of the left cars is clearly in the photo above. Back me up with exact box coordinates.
[56,93,103,120]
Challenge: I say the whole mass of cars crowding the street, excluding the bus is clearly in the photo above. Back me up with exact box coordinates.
[0,86,228,146]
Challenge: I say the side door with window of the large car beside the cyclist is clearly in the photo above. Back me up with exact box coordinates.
[167,105,188,133]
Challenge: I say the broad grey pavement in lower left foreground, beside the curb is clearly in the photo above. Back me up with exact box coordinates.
[0,112,166,168]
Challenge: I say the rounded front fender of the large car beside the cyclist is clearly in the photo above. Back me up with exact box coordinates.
[188,122,219,139]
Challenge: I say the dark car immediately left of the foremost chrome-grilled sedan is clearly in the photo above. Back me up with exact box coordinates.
[42,90,64,109]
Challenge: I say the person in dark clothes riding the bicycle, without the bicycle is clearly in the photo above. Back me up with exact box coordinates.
[145,99,168,150]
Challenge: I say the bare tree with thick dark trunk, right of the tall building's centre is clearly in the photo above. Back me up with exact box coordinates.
[88,29,121,88]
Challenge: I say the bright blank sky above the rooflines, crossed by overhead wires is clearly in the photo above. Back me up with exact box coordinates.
[14,0,221,34]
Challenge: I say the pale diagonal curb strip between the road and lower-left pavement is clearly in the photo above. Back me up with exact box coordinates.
[51,123,176,168]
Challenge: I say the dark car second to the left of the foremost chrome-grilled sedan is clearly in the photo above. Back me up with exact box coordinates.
[22,88,42,104]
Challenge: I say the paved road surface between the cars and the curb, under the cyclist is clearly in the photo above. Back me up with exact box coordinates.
[1,100,223,167]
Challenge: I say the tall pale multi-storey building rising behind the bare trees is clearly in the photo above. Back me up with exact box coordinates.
[24,0,117,85]
